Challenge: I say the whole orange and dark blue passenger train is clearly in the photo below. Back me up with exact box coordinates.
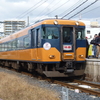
[0,19,86,77]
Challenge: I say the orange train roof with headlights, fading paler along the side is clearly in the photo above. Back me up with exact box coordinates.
[0,19,85,43]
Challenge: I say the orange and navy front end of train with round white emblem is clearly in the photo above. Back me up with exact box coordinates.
[37,19,86,77]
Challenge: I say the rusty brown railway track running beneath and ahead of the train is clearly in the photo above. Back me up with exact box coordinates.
[2,67,100,97]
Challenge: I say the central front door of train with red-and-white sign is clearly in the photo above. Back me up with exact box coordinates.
[62,27,75,61]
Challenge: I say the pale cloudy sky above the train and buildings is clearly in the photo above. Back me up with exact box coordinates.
[0,0,100,23]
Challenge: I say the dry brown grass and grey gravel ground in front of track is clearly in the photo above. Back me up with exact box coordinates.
[0,68,100,100]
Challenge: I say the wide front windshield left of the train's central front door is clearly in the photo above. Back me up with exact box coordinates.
[42,27,59,39]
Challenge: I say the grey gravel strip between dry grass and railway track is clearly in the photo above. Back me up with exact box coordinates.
[0,68,100,100]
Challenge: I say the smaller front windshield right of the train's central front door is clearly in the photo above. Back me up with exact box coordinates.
[75,28,85,40]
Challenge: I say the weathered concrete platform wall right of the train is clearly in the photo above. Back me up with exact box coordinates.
[85,58,100,82]
